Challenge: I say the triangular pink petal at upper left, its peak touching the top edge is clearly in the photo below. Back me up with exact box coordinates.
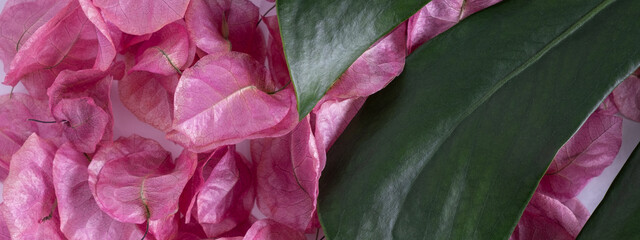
[4,1,116,86]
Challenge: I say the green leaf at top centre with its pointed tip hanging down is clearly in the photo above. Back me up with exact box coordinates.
[277,0,430,119]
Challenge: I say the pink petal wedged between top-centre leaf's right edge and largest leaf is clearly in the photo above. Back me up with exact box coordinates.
[324,24,407,99]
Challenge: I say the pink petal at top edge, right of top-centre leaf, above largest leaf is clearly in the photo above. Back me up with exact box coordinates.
[407,0,501,53]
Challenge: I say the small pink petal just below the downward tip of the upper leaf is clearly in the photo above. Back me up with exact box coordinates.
[312,98,366,154]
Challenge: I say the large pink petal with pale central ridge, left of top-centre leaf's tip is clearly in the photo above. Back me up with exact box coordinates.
[167,52,298,152]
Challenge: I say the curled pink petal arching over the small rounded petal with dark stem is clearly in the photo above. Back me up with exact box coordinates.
[47,68,117,142]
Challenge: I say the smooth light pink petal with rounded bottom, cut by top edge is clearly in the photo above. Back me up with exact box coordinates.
[93,0,189,35]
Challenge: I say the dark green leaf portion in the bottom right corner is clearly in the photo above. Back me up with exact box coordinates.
[577,142,640,240]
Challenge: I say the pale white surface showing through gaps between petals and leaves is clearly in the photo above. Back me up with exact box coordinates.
[0,0,640,233]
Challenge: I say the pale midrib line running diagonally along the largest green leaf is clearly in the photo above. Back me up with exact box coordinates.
[388,0,615,237]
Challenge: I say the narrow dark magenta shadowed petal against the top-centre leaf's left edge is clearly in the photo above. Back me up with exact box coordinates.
[262,16,291,89]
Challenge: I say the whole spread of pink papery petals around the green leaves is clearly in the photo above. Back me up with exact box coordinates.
[0,0,640,240]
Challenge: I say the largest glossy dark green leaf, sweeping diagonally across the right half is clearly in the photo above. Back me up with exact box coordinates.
[318,0,640,240]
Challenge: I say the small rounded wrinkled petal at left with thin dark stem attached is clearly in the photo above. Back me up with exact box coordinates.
[53,97,109,153]
